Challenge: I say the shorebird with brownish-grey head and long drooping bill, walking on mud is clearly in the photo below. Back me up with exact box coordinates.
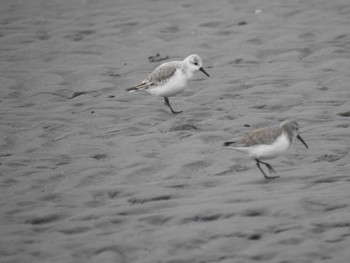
[224,121,309,179]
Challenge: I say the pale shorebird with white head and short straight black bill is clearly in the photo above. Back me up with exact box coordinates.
[126,55,209,114]
